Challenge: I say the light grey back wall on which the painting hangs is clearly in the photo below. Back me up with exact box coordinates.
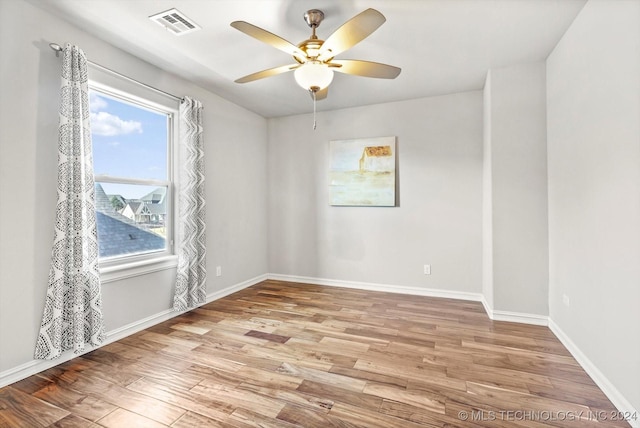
[268,91,482,294]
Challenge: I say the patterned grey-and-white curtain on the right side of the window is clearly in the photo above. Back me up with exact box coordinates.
[173,97,207,311]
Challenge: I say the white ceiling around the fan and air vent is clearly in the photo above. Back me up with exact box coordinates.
[32,0,586,117]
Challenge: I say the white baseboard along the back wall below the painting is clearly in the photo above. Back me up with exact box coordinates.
[268,273,482,302]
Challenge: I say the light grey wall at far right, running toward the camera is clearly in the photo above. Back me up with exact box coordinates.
[547,0,640,416]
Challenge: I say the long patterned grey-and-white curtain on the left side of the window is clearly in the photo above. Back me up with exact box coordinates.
[35,44,104,359]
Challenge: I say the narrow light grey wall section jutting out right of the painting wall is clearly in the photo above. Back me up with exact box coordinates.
[483,62,549,319]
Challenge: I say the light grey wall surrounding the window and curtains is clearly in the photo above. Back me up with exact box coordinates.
[0,0,267,375]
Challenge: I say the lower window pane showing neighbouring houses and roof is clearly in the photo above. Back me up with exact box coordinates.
[96,183,167,257]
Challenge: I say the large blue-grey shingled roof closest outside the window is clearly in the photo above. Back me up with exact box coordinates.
[96,183,165,257]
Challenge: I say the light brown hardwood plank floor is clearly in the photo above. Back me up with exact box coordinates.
[0,281,629,428]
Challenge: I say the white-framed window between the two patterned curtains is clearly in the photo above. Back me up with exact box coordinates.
[89,83,175,266]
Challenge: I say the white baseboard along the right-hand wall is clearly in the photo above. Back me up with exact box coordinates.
[549,318,640,428]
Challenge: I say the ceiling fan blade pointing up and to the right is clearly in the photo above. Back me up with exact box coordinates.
[318,9,386,60]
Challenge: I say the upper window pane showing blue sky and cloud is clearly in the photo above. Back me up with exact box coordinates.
[90,90,169,180]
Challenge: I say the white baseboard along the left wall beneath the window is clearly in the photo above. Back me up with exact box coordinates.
[0,275,267,388]
